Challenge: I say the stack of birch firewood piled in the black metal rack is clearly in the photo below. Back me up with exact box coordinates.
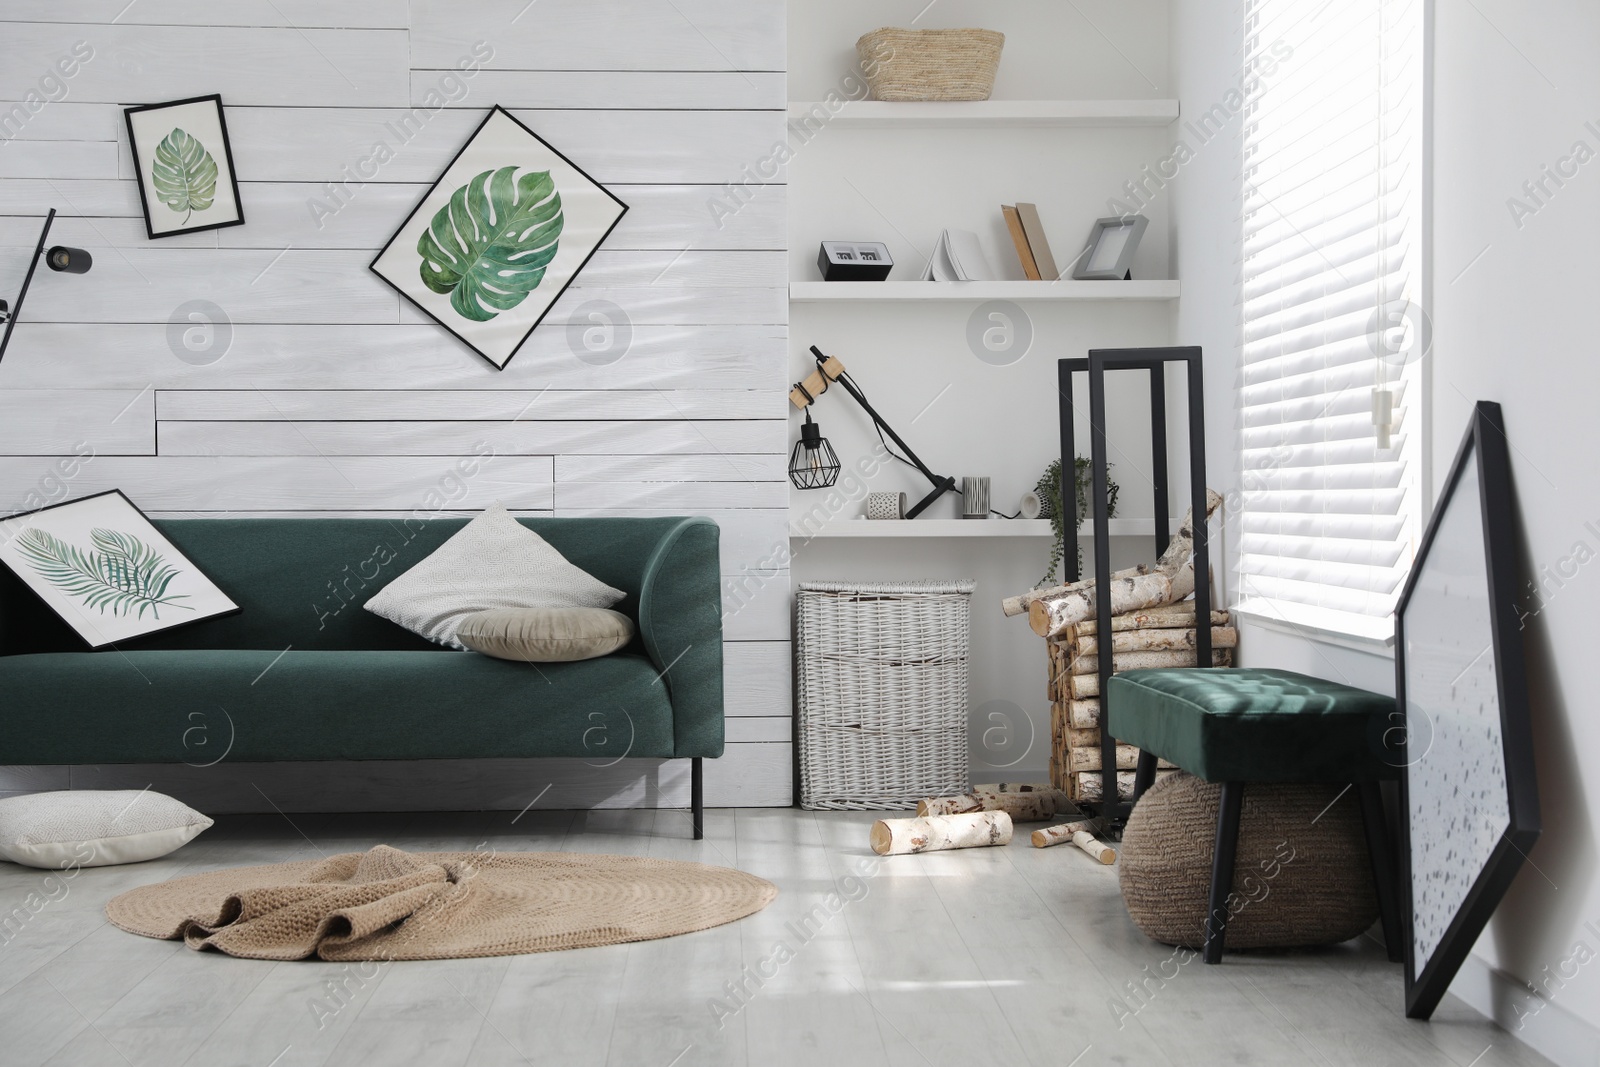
[1002,491,1238,801]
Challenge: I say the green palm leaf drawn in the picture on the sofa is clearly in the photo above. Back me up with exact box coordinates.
[16,526,194,619]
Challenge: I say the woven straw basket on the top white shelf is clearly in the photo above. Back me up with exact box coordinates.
[856,26,1005,101]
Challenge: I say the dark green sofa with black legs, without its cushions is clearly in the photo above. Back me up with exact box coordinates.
[0,518,723,838]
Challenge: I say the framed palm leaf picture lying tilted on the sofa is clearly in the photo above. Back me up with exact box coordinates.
[0,490,238,648]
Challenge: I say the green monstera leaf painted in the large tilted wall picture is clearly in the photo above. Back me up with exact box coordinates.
[416,166,566,322]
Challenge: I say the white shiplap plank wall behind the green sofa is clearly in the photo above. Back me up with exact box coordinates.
[0,0,790,809]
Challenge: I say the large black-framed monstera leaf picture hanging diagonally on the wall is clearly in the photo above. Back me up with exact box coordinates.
[373,107,627,368]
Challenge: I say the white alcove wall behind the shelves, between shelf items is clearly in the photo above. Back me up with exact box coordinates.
[789,0,1181,781]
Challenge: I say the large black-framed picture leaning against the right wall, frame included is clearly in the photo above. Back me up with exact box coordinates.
[1395,402,1539,1019]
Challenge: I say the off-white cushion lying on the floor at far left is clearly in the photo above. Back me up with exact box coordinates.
[0,789,211,870]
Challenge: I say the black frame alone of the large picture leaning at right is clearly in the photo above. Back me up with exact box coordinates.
[1395,400,1541,1019]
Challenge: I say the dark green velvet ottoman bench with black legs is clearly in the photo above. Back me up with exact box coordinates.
[1106,667,1400,963]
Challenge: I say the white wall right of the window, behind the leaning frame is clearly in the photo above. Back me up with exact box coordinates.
[1432,0,1600,1065]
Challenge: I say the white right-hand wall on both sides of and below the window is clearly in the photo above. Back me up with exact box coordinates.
[1171,0,1600,1065]
